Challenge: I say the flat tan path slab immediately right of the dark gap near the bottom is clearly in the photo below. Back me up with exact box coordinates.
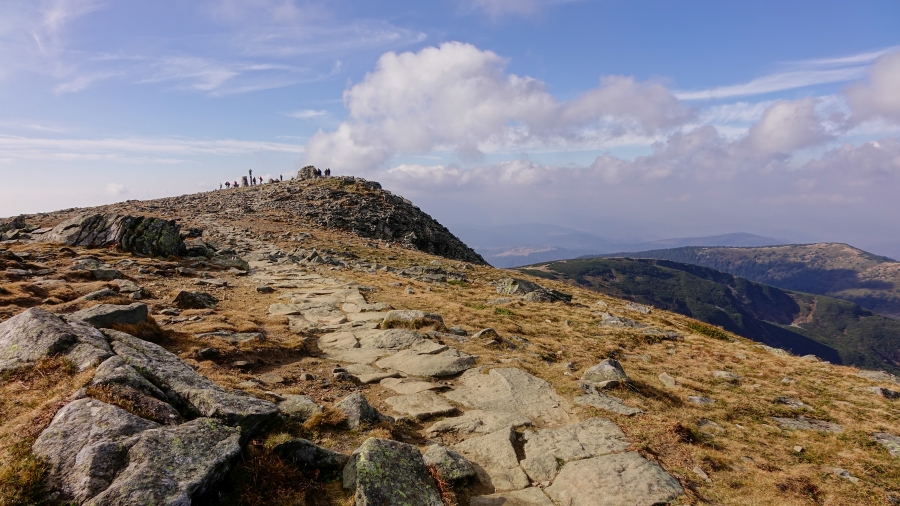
[521,418,629,482]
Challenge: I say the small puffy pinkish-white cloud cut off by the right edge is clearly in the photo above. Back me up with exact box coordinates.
[845,51,900,123]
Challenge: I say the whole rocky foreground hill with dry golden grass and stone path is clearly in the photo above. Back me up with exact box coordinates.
[0,178,900,506]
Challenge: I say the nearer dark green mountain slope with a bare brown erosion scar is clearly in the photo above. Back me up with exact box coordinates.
[523,258,900,372]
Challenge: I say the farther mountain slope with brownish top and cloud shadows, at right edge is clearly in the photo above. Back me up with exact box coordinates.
[601,243,900,319]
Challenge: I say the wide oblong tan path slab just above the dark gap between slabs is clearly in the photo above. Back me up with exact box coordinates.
[444,368,569,424]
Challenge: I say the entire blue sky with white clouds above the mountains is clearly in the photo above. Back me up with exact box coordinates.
[0,0,900,251]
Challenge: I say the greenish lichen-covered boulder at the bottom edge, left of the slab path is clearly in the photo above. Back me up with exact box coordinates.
[344,438,443,506]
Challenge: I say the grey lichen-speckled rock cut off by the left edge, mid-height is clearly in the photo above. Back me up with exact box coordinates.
[0,308,112,372]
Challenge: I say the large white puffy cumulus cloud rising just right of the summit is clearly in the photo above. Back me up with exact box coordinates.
[307,42,693,170]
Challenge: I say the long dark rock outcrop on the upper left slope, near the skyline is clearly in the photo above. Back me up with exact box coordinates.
[41,214,184,256]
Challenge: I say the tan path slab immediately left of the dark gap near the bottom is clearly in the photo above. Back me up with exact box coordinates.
[453,428,530,492]
